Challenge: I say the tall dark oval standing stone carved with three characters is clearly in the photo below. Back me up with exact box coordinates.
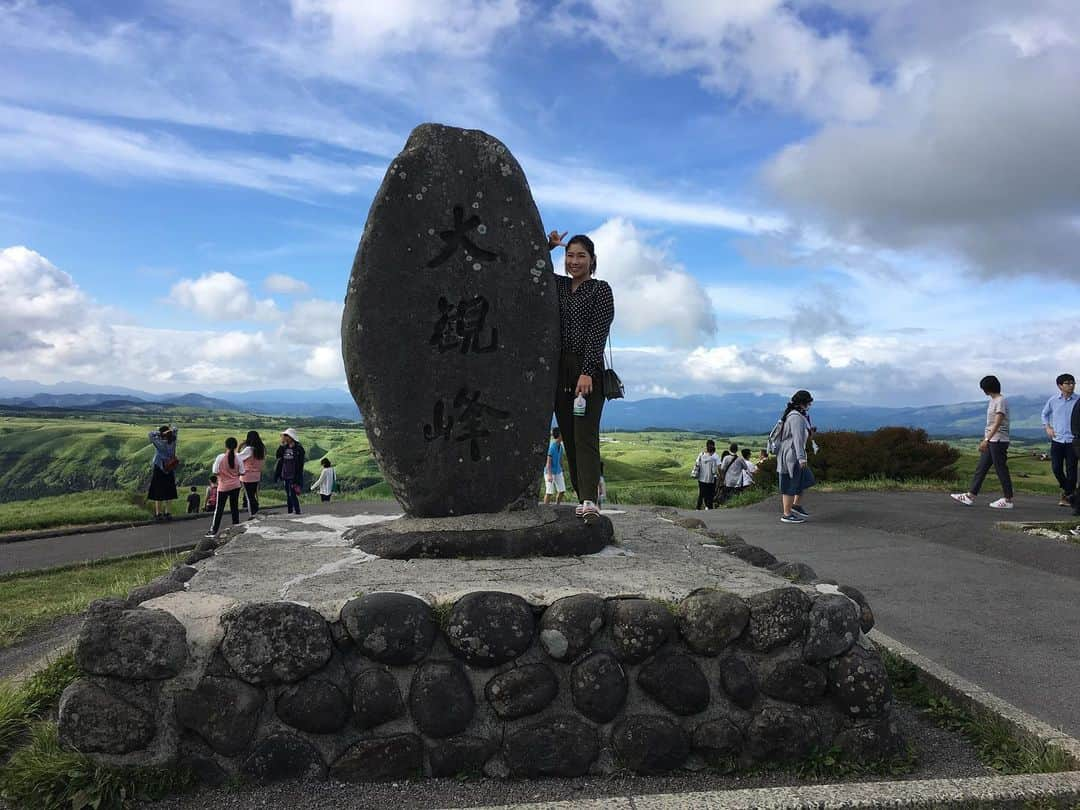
[341,124,558,517]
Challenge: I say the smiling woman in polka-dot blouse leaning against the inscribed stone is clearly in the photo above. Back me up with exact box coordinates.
[548,230,615,522]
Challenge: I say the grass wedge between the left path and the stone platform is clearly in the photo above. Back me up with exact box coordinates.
[0,554,179,649]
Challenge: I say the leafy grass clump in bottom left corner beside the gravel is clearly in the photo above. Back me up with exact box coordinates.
[0,723,193,810]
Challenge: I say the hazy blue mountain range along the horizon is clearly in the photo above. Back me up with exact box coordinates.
[0,377,1058,437]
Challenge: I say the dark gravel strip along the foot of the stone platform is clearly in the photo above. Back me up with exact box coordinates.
[143,704,994,810]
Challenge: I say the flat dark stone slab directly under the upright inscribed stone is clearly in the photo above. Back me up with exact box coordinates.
[345,505,615,559]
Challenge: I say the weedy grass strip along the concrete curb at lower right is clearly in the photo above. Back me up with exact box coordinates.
[881,650,1072,774]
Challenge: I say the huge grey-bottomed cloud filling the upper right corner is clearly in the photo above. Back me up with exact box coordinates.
[764,2,1080,280]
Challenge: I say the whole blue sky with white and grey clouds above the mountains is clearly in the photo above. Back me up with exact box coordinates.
[0,0,1080,404]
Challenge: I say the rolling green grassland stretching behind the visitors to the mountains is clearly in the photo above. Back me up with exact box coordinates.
[0,414,1057,540]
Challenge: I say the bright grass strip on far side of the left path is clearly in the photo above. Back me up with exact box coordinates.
[0,490,153,532]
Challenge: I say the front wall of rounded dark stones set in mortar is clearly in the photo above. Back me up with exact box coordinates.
[59,585,903,782]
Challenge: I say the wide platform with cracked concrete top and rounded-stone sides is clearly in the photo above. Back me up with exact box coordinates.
[58,510,904,783]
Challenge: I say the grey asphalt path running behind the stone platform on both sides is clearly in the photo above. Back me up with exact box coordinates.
[0,492,1080,737]
